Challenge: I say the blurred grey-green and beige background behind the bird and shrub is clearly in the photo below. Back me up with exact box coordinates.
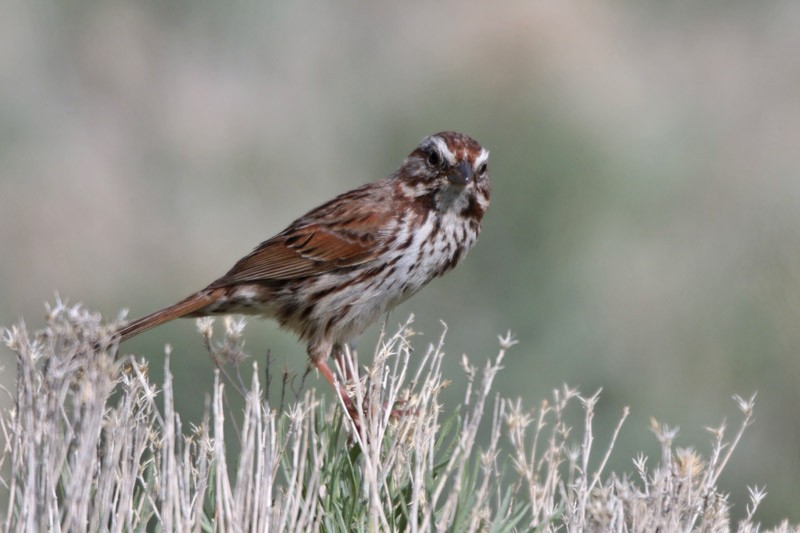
[0,0,800,525]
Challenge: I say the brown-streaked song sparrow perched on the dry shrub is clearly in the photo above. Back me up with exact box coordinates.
[119,131,491,414]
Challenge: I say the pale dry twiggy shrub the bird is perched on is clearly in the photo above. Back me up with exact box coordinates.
[0,300,791,532]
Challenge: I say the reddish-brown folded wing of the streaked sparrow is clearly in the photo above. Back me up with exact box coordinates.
[210,198,390,287]
